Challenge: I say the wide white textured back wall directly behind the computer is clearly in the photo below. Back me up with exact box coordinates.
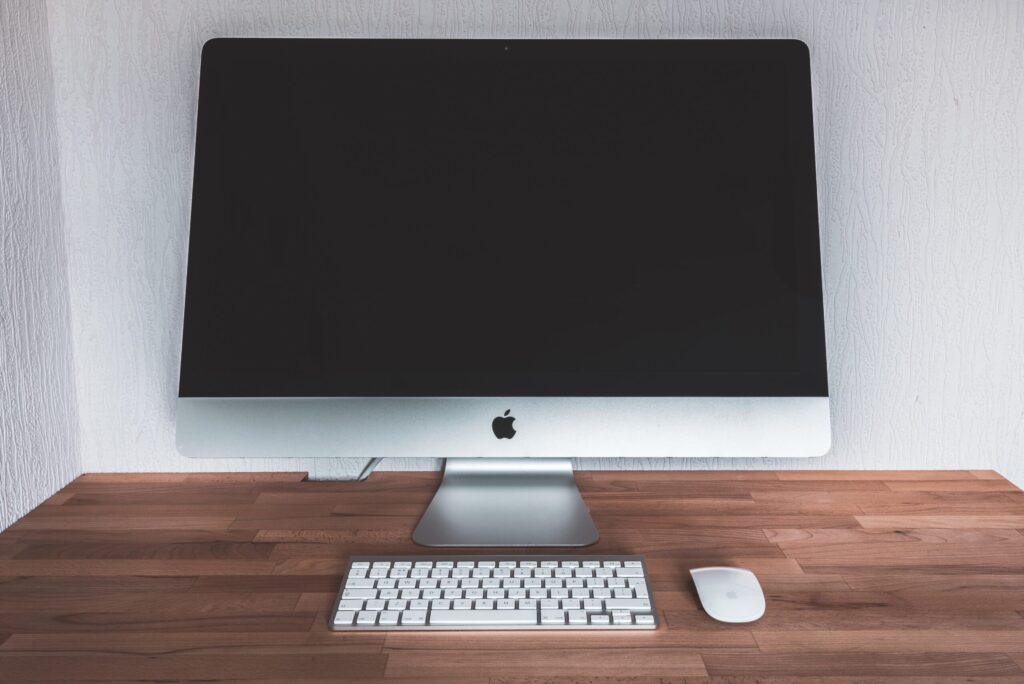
[48,0,1024,483]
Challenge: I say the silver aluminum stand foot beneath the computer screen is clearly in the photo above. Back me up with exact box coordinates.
[413,459,598,547]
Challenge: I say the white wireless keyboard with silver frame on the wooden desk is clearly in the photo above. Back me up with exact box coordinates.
[329,556,657,631]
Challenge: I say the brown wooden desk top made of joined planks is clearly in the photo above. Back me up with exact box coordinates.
[0,471,1024,684]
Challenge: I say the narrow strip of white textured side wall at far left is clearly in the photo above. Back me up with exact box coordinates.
[0,0,80,530]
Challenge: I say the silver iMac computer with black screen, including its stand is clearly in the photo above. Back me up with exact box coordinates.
[177,39,830,547]
